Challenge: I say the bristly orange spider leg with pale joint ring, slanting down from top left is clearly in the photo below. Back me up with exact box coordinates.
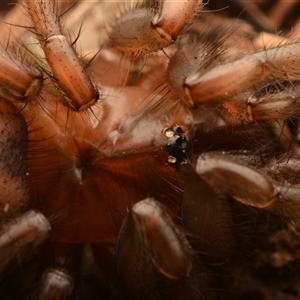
[25,0,99,111]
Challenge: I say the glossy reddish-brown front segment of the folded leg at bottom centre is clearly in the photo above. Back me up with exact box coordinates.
[132,199,192,279]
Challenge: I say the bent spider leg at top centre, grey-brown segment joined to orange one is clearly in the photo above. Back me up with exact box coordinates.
[110,0,202,58]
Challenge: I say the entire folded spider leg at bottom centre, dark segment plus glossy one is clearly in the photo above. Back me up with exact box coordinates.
[116,198,192,296]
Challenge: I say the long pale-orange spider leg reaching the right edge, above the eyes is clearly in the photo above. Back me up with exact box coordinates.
[185,42,300,105]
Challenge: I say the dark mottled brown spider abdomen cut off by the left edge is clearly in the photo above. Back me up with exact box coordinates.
[0,99,29,218]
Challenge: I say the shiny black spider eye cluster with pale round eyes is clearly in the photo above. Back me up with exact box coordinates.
[165,125,189,169]
